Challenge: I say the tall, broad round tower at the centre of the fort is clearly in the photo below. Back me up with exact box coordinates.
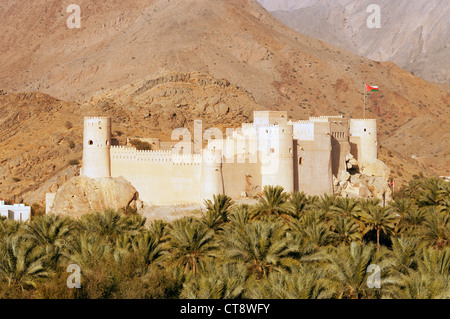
[259,125,294,192]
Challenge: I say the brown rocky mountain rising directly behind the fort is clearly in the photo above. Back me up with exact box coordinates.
[0,0,450,203]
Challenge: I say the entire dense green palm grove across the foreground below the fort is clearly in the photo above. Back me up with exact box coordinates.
[0,178,450,299]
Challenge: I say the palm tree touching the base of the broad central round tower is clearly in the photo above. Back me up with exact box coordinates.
[255,186,290,221]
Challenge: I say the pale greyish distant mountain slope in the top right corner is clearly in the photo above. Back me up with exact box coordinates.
[260,0,450,83]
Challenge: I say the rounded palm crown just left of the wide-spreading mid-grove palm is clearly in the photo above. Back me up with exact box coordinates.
[166,217,217,275]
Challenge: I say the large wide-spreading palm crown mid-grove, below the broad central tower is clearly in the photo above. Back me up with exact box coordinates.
[223,221,298,278]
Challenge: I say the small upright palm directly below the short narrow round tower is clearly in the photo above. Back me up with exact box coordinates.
[202,194,234,231]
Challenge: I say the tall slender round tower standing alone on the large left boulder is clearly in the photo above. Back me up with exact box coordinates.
[81,117,111,178]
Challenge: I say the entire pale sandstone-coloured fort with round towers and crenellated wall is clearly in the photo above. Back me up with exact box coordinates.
[74,111,377,205]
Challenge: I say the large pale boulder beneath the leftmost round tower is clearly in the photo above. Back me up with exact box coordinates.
[48,176,141,218]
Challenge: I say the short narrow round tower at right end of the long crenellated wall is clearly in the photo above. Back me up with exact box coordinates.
[201,149,224,202]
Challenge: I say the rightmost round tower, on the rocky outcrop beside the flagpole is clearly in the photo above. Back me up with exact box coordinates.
[350,119,378,163]
